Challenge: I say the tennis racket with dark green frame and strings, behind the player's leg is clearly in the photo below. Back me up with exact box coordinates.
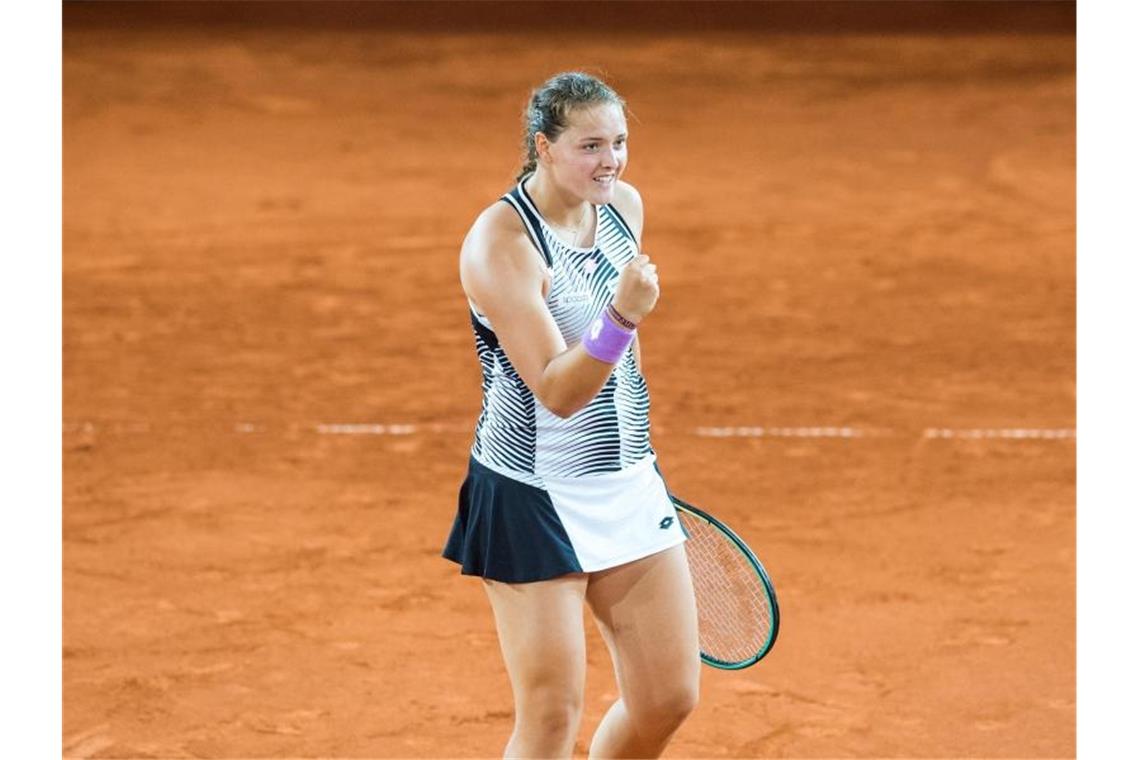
[669,493,780,670]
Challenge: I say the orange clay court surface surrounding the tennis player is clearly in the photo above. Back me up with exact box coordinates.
[63,13,1075,758]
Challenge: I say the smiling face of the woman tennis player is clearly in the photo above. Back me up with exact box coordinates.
[544,103,628,205]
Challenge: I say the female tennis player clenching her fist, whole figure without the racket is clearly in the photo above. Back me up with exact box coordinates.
[443,72,700,758]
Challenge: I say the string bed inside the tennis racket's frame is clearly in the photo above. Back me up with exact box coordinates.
[678,512,772,663]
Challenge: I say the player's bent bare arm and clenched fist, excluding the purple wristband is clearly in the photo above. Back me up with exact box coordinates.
[459,204,657,417]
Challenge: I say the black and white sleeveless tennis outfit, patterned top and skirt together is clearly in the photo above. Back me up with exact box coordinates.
[443,182,685,583]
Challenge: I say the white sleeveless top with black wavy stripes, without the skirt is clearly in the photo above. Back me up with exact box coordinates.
[469,181,656,488]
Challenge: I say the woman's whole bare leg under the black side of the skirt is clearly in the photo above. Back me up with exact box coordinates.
[485,574,586,758]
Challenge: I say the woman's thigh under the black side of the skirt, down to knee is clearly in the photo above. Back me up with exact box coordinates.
[483,574,587,702]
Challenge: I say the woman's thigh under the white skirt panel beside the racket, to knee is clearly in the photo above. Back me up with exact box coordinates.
[586,545,700,711]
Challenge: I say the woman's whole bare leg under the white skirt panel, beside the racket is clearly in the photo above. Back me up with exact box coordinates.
[586,546,700,758]
